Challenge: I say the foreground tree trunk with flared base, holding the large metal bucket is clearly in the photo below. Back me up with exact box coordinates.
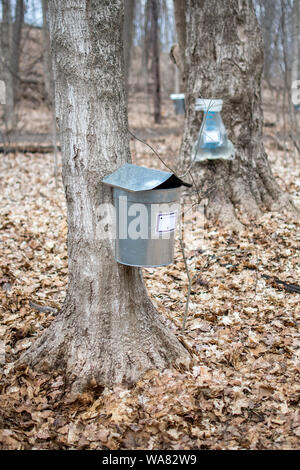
[21,0,189,395]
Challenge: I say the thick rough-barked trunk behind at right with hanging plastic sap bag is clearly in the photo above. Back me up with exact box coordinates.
[175,0,293,230]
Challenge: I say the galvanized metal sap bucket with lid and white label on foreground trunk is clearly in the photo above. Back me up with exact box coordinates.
[103,164,190,267]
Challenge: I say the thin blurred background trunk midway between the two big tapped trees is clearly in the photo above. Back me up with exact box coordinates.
[150,0,161,124]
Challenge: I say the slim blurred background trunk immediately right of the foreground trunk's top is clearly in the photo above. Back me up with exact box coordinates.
[123,0,135,92]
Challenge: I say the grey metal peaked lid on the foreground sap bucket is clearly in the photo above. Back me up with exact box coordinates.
[102,163,192,192]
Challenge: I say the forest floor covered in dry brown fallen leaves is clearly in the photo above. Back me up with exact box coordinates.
[0,91,300,449]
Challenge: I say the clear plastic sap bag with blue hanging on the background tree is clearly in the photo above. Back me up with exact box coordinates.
[192,98,235,162]
